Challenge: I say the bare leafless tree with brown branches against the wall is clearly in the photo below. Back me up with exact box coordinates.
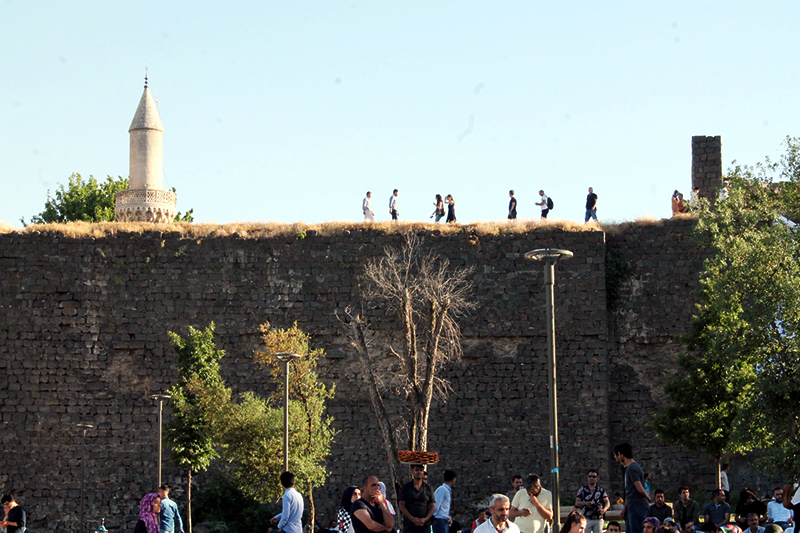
[342,233,474,490]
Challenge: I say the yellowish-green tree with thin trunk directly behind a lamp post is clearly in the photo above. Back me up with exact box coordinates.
[252,323,336,531]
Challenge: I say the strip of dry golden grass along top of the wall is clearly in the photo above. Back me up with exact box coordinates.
[9,219,603,239]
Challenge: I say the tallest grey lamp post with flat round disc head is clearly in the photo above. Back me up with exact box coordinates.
[525,248,572,533]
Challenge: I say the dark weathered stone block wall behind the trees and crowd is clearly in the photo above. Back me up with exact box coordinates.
[0,220,708,531]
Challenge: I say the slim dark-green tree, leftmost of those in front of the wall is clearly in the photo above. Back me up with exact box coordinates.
[165,322,231,533]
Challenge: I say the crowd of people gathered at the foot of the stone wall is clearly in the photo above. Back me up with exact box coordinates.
[119,436,800,533]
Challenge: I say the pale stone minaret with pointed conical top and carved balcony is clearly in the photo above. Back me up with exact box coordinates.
[114,76,177,223]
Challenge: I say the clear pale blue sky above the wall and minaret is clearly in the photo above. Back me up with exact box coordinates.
[0,0,800,226]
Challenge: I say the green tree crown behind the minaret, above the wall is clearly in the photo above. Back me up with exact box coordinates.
[20,172,194,225]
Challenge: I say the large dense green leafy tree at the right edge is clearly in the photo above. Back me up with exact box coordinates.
[655,138,800,477]
